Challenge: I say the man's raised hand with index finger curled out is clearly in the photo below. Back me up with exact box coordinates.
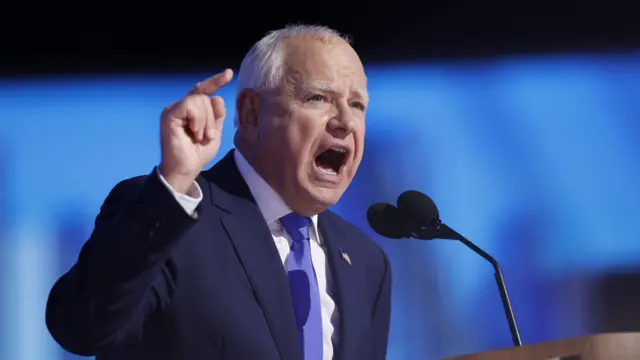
[160,69,233,194]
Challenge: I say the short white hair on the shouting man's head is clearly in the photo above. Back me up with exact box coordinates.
[234,25,351,127]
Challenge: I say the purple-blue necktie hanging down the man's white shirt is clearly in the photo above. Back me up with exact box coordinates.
[280,213,322,360]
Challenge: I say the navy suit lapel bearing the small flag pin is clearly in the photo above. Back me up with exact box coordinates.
[318,211,367,360]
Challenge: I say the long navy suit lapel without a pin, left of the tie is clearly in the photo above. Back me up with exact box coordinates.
[203,150,302,360]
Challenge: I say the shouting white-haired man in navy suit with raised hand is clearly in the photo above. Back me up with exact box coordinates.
[46,26,391,360]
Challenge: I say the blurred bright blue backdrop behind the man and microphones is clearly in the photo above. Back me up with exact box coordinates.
[0,53,640,360]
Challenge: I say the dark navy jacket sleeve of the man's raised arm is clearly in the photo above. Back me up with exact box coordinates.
[46,169,199,356]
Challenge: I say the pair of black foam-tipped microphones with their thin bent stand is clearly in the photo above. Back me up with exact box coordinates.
[367,190,522,347]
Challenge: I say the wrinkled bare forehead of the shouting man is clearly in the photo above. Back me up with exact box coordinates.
[282,38,368,97]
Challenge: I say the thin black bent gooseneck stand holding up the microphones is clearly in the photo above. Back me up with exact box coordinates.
[411,220,522,347]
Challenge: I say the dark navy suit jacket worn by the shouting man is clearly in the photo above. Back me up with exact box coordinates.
[46,152,391,360]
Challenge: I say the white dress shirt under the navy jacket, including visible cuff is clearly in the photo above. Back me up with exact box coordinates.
[158,149,338,360]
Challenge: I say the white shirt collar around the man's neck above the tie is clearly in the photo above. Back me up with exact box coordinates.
[233,149,320,239]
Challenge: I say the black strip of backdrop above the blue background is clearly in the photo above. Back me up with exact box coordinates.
[0,0,640,75]
